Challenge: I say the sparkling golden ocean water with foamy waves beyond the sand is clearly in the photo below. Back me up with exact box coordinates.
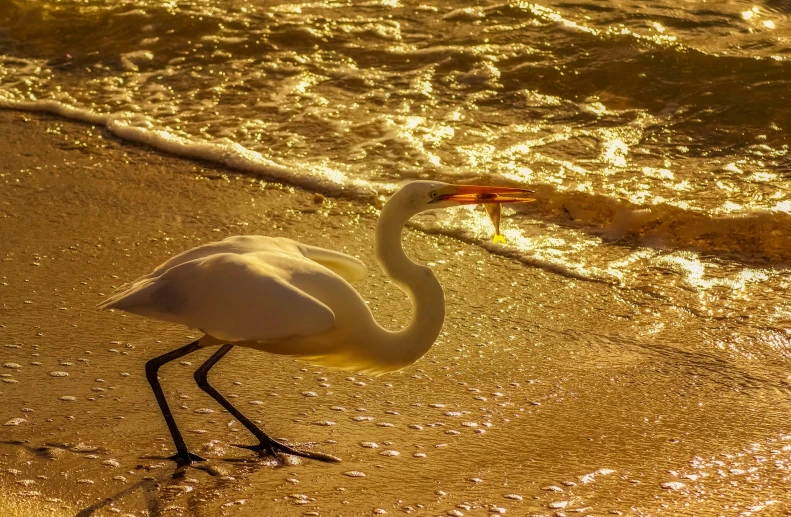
[0,0,791,512]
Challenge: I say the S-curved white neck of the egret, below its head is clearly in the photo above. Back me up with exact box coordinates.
[375,195,445,366]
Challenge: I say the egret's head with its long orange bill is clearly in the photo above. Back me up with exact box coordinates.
[392,181,533,213]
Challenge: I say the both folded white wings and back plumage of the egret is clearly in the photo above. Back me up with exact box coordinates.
[102,235,365,343]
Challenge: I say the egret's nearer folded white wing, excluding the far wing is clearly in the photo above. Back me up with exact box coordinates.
[101,253,335,342]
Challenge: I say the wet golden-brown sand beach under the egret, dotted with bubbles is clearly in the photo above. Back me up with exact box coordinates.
[0,111,791,516]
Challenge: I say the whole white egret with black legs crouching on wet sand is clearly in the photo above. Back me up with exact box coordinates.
[100,181,532,465]
